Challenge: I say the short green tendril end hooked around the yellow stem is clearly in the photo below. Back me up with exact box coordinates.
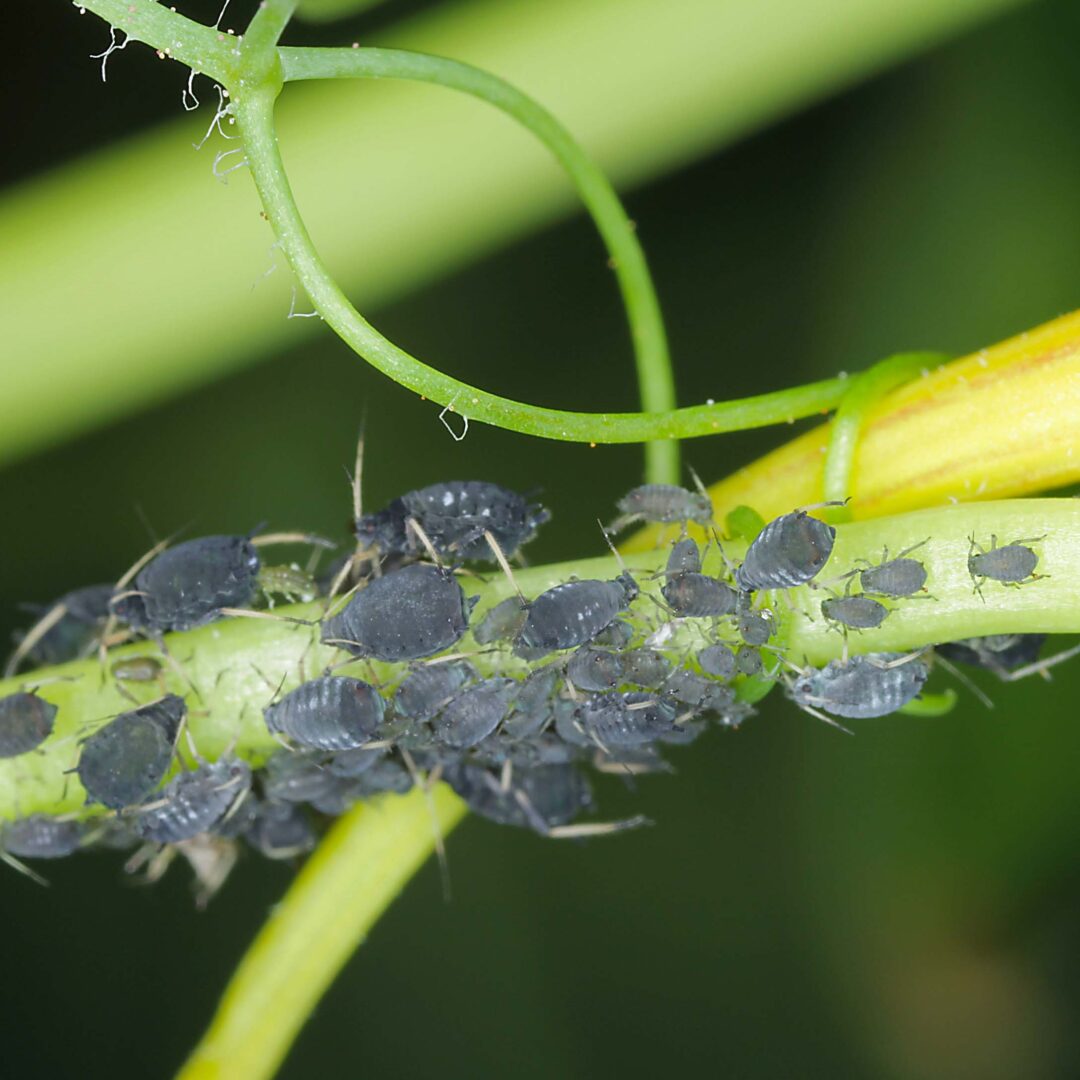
[824,352,951,522]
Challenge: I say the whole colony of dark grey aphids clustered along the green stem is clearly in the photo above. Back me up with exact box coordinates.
[0,481,1062,894]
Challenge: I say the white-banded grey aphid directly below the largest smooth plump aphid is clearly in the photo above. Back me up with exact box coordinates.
[262,675,386,750]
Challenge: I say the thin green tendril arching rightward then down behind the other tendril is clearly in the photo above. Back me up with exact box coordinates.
[279,49,678,483]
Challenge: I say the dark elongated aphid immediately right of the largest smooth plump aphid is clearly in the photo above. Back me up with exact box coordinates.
[514,572,637,656]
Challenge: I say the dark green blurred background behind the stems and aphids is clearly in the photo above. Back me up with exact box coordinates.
[0,0,1080,1080]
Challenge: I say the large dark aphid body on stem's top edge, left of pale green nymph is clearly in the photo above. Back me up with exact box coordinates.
[112,536,260,634]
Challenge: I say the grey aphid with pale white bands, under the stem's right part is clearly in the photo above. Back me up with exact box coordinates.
[789,652,928,720]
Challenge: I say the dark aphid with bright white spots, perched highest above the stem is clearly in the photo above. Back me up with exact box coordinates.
[355,480,551,563]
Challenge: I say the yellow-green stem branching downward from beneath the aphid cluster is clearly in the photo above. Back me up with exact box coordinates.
[178,784,465,1080]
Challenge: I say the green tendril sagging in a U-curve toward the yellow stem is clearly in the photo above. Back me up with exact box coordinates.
[233,65,847,443]
